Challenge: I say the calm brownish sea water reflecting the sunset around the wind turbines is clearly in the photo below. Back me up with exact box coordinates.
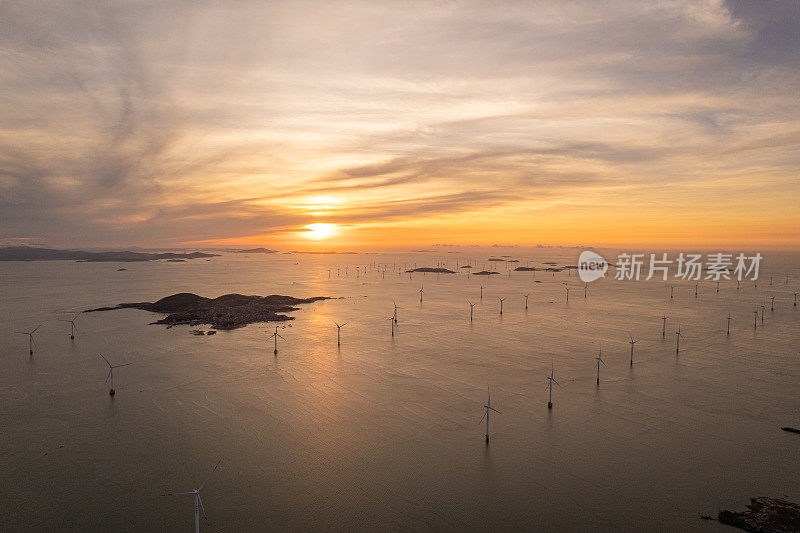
[0,250,800,531]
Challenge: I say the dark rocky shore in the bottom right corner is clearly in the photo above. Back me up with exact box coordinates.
[717,497,800,533]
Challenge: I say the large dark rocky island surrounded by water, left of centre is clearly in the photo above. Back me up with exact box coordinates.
[85,292,331,329]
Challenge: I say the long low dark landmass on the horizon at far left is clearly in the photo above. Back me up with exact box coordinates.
[0,246,219,263]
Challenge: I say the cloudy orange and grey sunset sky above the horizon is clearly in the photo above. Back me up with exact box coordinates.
[0,0,800,250]
